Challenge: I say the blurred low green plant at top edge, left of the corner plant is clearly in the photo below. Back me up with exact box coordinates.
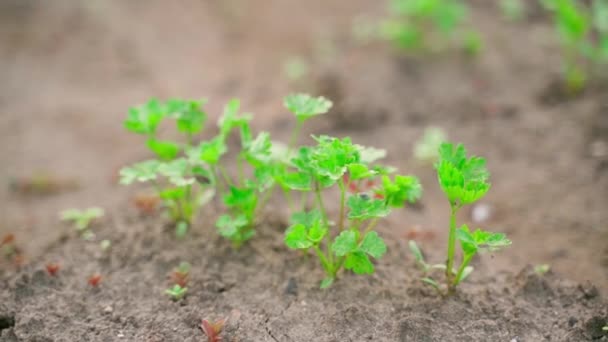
[380,0,482,55]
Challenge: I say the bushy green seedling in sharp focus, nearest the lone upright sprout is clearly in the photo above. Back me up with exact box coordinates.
[283,136,421,288]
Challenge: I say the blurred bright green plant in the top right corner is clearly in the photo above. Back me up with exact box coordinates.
[542,0,608,95]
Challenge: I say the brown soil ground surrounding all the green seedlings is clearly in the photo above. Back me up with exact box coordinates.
[0,0,608,342]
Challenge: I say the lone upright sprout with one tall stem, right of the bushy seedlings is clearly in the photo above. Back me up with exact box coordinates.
[410,143,511,295]
